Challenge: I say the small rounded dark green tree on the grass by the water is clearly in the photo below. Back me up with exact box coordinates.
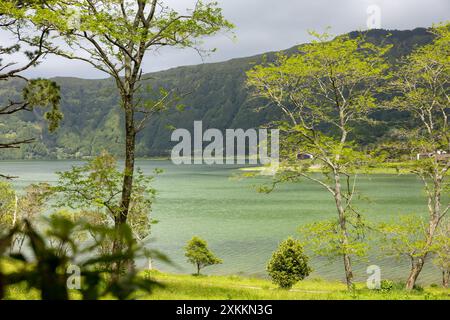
[267,238,312,289]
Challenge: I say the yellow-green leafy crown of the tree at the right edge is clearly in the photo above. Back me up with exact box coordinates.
[388,24,450,159]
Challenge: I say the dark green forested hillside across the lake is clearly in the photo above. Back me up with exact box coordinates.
[0,28,432,159]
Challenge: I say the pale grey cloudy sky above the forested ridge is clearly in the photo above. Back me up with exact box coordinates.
[6,0,450,78]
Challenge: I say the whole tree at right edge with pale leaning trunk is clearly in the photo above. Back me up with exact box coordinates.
[389,24,450,290]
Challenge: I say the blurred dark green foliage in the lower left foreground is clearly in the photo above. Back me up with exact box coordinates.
[0,215,162,300]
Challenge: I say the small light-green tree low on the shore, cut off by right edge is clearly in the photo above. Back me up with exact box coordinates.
[433,219,450,288]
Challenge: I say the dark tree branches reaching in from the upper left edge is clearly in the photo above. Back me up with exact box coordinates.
[0,1,62,179]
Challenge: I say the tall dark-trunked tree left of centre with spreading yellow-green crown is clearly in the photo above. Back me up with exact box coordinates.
[7,0,233,260]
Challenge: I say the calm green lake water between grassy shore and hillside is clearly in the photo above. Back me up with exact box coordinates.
[0,160,441,284]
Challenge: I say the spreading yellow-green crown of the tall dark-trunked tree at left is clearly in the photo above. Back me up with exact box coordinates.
[0,0,234,156]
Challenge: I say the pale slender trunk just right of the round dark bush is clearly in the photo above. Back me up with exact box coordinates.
[334,173,353,290]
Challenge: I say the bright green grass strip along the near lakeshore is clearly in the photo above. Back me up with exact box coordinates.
[7,271,450,300]
